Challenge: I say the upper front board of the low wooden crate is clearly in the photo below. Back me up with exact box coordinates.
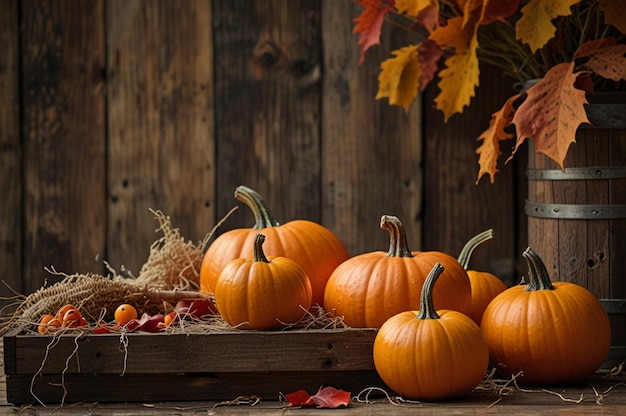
[4,329,376,375]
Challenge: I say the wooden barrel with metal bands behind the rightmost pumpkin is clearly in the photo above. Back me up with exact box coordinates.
[525,93,626,369]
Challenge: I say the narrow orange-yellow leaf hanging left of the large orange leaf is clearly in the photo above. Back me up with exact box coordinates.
[476,94,520,183]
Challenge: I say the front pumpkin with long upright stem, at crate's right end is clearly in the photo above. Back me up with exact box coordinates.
[373,263,489,400]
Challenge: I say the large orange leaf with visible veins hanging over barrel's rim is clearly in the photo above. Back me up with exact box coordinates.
[507,62,589,169]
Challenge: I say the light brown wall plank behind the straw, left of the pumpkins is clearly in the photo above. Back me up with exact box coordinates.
[107,0,215,274]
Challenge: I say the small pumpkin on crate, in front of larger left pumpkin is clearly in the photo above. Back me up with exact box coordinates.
[215,234,312,330]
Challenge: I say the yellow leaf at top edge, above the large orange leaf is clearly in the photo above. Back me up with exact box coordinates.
[515,0,580,53]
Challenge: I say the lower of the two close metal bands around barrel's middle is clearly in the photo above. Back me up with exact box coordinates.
[524,200,626,220]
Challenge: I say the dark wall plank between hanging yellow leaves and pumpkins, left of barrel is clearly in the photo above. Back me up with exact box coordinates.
[423,67,525,285]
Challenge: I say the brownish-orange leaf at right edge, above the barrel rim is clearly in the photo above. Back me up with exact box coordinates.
[574,38,626,81]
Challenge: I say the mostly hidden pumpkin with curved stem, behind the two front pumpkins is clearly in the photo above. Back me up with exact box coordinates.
[458,229,506,325]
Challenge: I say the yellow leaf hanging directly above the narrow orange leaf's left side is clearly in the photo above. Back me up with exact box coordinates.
[435,36,480,121]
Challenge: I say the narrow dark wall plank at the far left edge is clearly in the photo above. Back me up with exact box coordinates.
[0,0,23,300]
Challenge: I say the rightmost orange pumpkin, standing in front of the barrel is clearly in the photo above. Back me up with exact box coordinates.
[481,247,611,385]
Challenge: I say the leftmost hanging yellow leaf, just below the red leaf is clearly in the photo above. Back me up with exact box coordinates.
[376,45,422,111]
